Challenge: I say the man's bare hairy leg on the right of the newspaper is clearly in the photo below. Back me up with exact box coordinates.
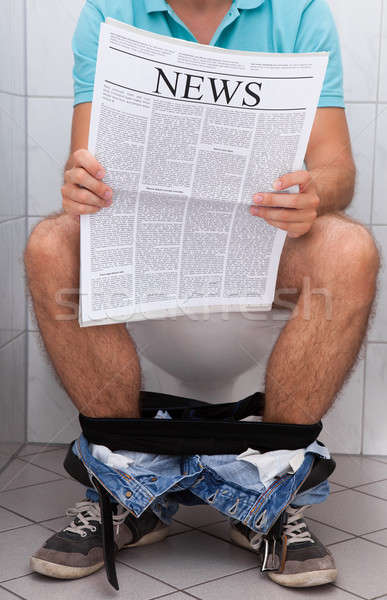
[264,213,379,424]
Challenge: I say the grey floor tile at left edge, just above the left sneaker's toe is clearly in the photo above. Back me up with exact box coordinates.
[0,479,85,530]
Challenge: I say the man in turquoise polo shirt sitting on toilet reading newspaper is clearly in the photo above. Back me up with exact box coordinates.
[25,0,379,587]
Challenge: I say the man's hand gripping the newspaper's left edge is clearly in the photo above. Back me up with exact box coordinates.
[62,150,113,215]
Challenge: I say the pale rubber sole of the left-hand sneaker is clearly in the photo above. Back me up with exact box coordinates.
[30,527,169,579]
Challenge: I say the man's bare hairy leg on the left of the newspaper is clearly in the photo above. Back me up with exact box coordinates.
[25,215,140,418]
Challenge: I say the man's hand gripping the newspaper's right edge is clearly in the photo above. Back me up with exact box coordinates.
[250,171,320,238]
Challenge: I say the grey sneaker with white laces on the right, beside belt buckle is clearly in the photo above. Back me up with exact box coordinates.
[230,506,337,588]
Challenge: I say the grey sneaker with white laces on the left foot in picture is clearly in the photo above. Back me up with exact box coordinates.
[30,500,168,579]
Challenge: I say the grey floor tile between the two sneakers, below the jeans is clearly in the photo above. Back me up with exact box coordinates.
[119,531,257,588]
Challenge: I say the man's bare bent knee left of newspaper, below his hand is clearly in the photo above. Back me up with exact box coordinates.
[24,215,79,276]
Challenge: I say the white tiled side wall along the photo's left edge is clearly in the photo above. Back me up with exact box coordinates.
[0,0,27,468]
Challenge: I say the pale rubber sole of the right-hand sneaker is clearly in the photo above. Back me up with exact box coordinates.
[230,527,337,588]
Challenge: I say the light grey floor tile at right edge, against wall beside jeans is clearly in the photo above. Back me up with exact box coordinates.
[331,454,387,487]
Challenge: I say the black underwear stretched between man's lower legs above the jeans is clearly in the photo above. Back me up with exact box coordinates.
[79,392,322,455]
